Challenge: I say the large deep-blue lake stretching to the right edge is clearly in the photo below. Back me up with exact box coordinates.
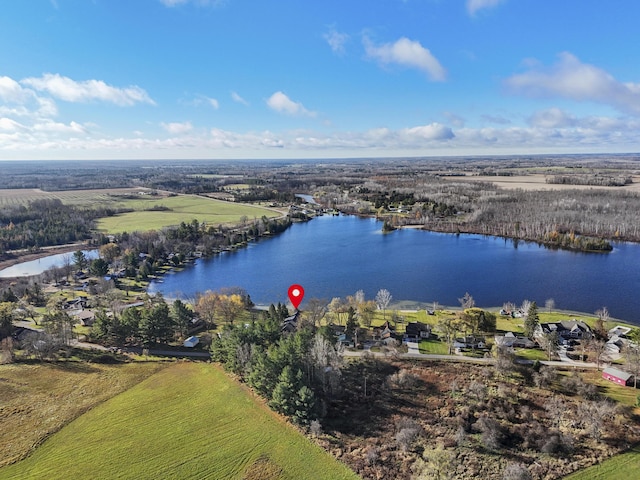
[150,216,640,322]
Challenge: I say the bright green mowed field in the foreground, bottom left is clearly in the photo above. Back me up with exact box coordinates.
[0,362,358,480]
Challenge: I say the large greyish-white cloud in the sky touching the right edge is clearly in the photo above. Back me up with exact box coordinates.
[505,52,640,115]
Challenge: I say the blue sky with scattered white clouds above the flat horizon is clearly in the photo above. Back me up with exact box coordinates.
[0,0,640,160]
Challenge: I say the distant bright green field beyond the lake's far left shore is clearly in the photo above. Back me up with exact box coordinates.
[97,195,280,234]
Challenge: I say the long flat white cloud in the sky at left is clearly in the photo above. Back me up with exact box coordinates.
[20,73,155,106]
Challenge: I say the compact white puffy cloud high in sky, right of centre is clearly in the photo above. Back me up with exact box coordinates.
[363,37,447,82]
